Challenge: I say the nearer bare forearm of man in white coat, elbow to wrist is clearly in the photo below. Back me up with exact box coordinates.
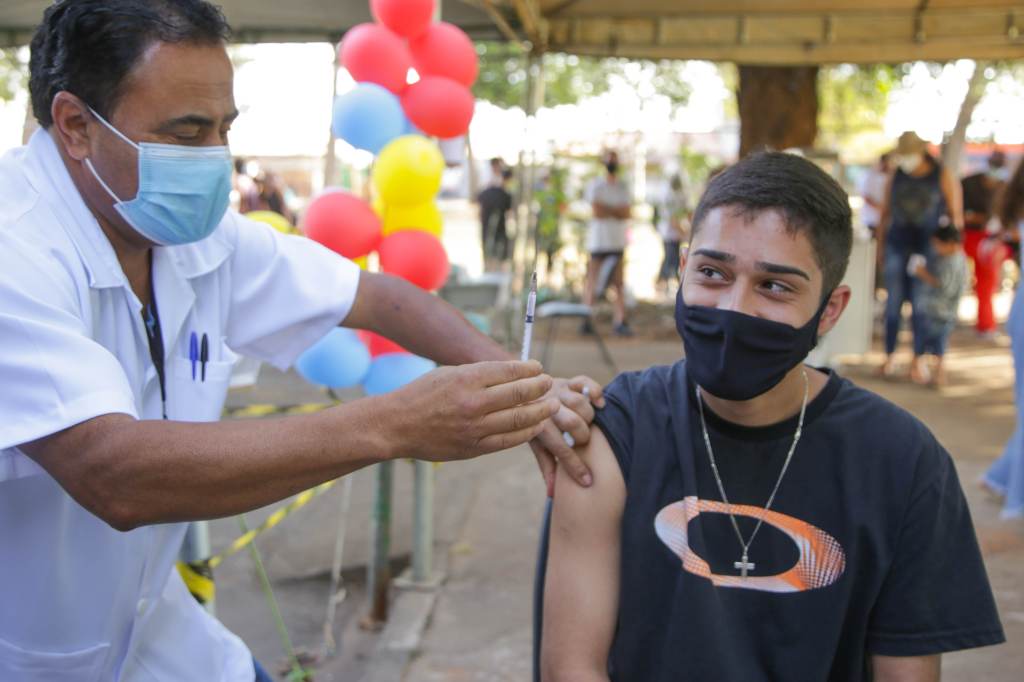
[23,398,391,530]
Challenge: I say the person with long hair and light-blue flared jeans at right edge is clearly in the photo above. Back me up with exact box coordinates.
[982,157,1024,518]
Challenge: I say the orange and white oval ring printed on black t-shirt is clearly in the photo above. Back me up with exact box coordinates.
[654,497,846,592]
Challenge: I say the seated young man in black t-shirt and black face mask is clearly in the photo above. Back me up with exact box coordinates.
[543,154,1004,682]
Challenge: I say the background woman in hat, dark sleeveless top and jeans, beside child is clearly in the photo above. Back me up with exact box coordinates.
[876,131,964,383]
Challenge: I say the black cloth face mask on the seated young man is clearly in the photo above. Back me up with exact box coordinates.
[676,287,828,400]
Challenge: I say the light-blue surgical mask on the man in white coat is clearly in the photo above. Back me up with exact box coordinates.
[85,106,232,246]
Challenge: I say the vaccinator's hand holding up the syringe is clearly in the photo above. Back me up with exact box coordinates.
[380,361,561,462]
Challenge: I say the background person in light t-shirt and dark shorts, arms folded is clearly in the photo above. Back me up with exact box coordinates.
[580,151,633,336]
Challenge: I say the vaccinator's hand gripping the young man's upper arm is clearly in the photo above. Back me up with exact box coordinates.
[529,376,604,498]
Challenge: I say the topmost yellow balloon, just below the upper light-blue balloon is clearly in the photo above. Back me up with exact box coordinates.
[373,135,444,207]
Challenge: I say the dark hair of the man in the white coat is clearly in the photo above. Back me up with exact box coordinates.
[29,0,230,128]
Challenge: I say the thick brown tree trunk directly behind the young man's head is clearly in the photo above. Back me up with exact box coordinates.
[736,65,818,158]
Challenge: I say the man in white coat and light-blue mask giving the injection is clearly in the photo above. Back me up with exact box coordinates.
[0,0,600,682]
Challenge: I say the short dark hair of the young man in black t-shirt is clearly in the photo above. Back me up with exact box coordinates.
[693,152,853,294]
